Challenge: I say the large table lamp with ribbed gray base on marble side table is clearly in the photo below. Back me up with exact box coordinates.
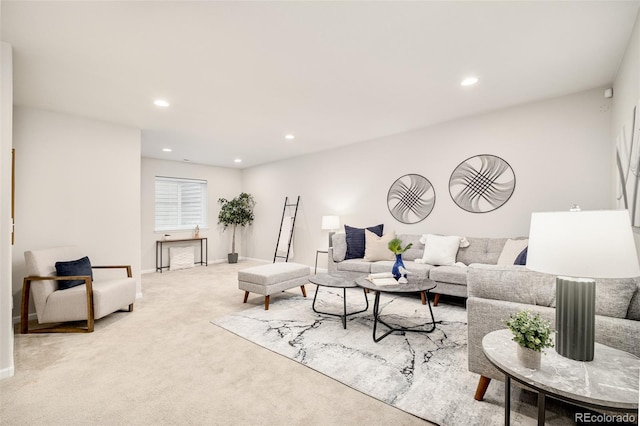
[527,209,640,361]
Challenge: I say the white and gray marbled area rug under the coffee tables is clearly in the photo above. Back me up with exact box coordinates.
[211,288,575,425]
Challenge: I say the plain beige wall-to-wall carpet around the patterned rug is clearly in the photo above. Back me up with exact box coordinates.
[0,261,436,425]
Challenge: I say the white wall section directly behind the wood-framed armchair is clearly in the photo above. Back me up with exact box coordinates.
[13,107,141,316]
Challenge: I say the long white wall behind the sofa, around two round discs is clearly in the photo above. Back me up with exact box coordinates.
[243,88,613,265]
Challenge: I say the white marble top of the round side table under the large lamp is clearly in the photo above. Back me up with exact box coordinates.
[482,329,640,411]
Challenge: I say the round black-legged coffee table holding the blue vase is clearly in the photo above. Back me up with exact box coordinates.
[356,277,442,342]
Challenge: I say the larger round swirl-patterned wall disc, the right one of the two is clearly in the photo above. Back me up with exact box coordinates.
[449,155,516,213]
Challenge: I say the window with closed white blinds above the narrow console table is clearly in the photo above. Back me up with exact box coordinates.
[155,176,207,231]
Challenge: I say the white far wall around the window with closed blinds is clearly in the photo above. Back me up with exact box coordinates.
[140,158,245,272]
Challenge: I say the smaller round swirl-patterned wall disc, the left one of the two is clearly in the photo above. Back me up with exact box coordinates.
[387,174,436,224]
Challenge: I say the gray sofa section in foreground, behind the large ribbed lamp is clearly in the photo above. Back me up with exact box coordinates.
[467,265,640,400]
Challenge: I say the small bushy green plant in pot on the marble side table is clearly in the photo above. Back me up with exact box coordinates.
[504,310,553,370]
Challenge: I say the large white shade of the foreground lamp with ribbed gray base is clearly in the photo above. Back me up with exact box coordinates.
[527,210,640,278]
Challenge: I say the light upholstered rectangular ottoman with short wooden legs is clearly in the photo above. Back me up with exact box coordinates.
[238,262,309,310]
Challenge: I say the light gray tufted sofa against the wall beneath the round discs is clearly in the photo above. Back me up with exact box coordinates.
[328,233,507,306]
